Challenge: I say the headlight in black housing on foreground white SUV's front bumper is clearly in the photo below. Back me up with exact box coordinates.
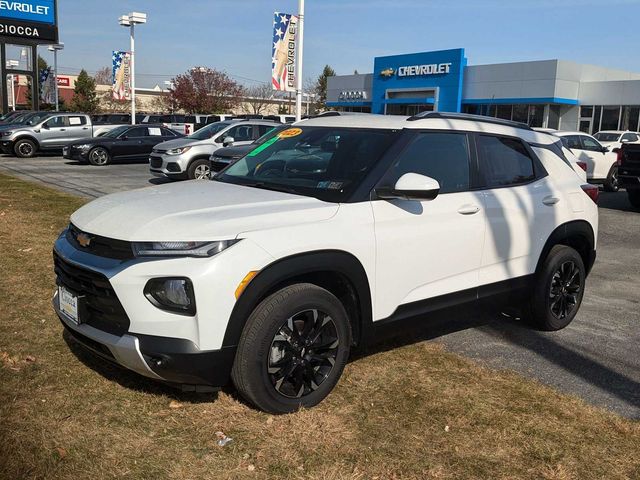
[144,278,196,316]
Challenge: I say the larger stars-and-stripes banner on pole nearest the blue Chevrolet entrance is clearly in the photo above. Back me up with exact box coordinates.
[271,12,298,92]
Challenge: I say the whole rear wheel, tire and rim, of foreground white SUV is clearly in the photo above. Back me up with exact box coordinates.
[526,245,586,331]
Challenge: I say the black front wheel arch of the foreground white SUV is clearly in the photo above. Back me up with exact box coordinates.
[222,250,373,347]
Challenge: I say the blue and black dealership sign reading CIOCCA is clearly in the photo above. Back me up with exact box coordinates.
[0,0,58,43]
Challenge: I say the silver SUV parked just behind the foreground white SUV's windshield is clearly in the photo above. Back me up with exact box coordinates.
[149,120,278,180]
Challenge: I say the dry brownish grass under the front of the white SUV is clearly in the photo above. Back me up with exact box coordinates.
[0,175,640,480]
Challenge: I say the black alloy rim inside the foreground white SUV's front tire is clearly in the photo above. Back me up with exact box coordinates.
[267,309,340,398]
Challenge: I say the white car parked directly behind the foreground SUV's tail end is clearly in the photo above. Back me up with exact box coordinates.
[554,132,620,192]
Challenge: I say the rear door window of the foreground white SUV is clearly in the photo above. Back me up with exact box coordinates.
[478,135,535,188]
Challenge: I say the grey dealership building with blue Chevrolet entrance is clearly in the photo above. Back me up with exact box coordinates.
[327,49,640,133]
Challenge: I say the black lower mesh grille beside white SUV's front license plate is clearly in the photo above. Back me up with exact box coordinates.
[53,251,129,336]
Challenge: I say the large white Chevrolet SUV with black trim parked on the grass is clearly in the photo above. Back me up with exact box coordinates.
[53,113,598,413]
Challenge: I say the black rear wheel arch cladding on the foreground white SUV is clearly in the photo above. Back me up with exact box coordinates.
[536,220,595,274]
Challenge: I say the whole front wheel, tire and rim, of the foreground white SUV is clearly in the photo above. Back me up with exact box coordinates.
[231,283,351,414]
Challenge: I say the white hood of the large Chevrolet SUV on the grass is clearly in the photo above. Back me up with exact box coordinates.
[71,180,339,241]
